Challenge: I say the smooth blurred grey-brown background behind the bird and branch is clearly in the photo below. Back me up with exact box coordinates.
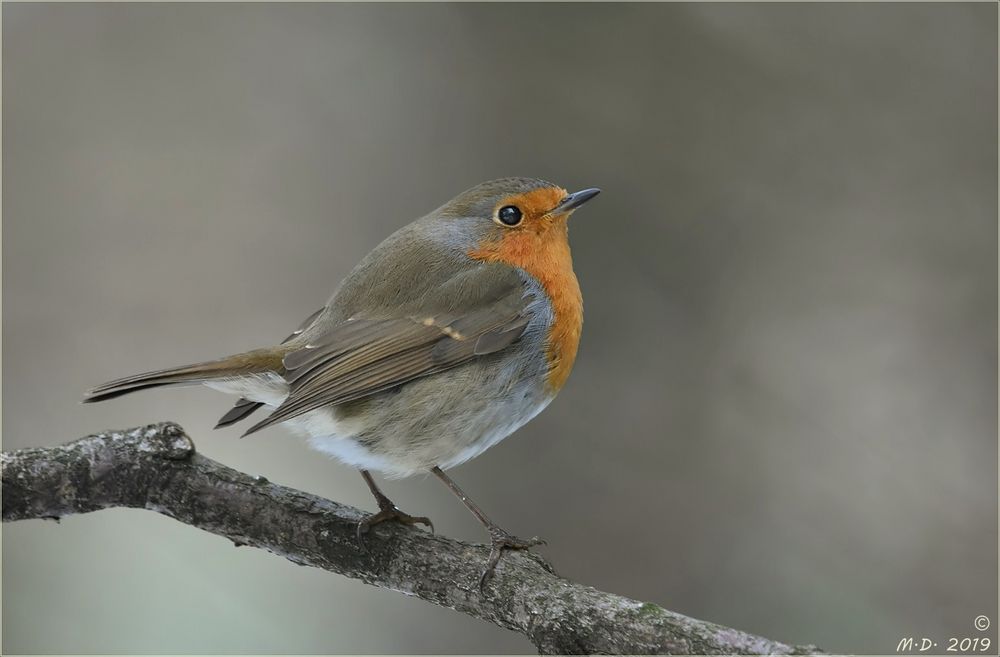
[2,4,998,653]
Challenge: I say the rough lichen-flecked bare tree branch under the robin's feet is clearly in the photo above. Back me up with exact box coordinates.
[0,423,817,654]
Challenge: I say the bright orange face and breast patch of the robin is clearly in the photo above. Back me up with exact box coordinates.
[469,187,583,391]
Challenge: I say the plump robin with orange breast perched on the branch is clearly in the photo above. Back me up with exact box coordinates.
[84,178,600,587]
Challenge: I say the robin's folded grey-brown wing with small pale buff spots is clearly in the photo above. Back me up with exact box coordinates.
[241,277,531,434]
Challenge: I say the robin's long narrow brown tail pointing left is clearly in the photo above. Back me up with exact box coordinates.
[83,348,284,403]
